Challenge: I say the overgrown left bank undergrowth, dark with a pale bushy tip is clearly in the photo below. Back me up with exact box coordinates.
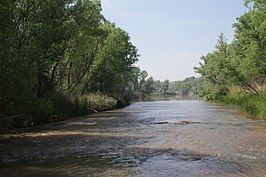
[0,93,118,133]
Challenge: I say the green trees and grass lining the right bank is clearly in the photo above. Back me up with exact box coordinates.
[195,0,266,117]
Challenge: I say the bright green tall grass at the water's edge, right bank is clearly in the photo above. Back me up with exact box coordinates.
[218,92,266,119]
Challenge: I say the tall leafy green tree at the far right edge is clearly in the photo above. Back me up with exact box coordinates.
[233,0,266,94]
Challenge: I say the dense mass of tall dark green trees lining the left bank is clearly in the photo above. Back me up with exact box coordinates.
[0,0,148,128]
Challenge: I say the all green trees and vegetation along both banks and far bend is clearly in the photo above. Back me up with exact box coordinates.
[0,0,266,130]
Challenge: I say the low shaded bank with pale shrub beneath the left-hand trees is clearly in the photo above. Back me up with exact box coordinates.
[0,93,123,133]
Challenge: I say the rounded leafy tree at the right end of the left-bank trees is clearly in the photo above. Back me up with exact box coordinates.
[85,22,138,103]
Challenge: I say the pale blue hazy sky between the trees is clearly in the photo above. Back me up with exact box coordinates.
[102,0,247,81]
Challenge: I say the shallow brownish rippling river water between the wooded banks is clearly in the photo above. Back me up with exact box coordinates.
[0,100,266,177]
